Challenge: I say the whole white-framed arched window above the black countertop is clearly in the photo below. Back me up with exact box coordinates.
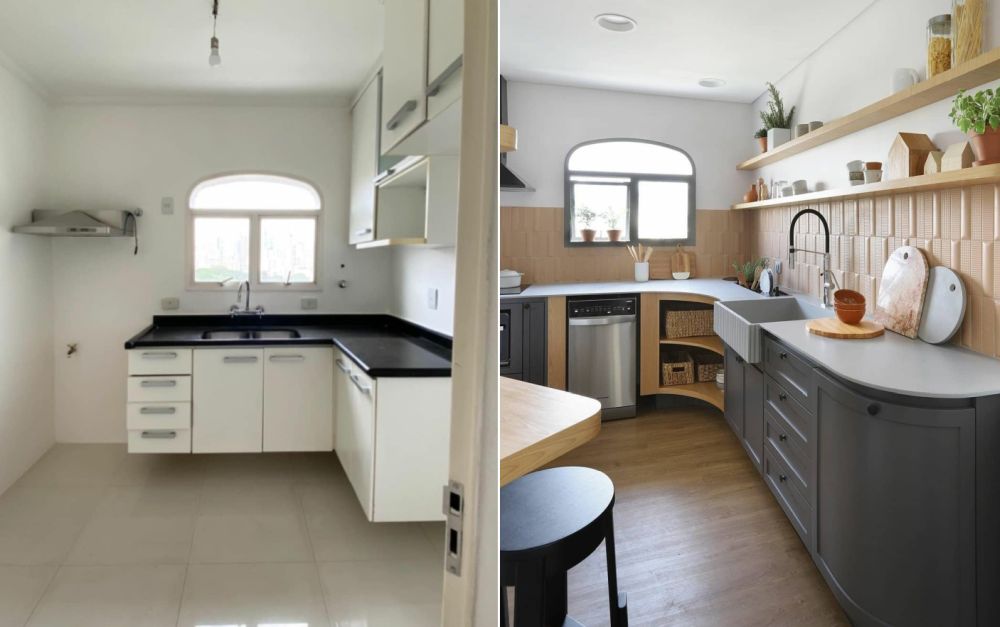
[188,173,323,289]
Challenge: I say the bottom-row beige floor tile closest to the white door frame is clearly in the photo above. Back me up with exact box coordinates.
[319,559,444,627]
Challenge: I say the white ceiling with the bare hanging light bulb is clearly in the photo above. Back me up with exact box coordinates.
[0,0,383,103]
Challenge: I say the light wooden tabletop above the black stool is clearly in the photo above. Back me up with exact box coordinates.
[500,377,601,485]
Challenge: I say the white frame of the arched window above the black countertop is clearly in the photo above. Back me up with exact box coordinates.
[184,170,326,292]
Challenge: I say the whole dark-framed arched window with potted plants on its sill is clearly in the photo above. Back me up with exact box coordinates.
[565,139,695,246]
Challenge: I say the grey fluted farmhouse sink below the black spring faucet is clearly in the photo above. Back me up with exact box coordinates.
[715,296,833,364]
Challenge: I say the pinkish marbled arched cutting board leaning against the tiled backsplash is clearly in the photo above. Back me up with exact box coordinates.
[872,246,929,338]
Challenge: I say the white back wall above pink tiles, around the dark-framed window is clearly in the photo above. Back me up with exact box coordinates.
[500,82,752,209]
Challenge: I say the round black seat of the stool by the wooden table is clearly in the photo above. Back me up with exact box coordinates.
[500,466,615,553]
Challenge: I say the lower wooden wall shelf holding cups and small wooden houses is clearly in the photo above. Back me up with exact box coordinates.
[732,164,1000,209]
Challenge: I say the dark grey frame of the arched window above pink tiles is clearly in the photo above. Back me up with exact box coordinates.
[563,137,698,247]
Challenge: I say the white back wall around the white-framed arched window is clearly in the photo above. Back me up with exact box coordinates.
[41,106,392,442]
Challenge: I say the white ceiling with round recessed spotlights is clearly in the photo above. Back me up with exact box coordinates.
[500,0,876,102]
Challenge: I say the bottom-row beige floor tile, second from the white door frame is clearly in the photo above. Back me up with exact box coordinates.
[177,564,326,627]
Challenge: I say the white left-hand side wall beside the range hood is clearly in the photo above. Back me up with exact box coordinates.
[0,60,53,492]
